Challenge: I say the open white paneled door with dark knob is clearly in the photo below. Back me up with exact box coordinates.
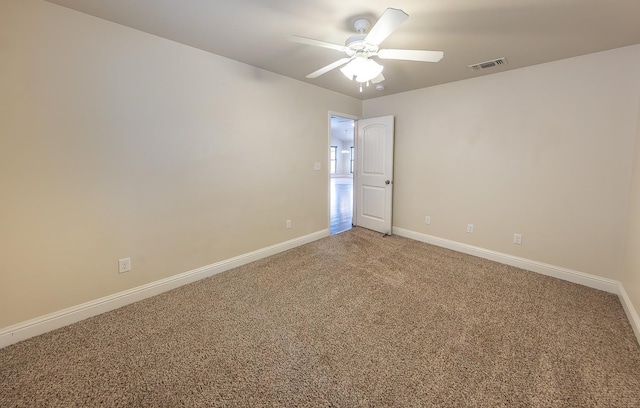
[354,116,394,235]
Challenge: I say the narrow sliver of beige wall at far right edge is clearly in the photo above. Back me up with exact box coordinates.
[620,95,640,328]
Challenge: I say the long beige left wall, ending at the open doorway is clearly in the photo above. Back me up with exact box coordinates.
[0,0,362,328]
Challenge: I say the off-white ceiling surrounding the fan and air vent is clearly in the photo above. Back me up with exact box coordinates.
[43,0,640,99]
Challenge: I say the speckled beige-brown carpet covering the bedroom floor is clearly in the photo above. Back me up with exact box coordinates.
[0,228,640,407]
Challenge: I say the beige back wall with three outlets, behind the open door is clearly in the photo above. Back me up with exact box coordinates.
[363,46,640,280]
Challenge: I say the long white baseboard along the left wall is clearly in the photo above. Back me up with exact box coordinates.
[0,229,329,348]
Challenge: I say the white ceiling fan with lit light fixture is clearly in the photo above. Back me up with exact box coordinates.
[289,8,444,92]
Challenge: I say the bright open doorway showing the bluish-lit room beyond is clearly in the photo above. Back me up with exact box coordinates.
[329,115,356,235]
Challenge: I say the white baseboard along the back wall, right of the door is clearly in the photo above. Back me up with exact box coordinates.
[393,227,620,295]
